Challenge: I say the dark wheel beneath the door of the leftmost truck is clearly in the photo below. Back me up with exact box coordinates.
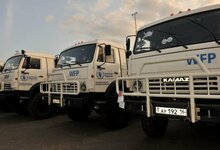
[28,93,54,119]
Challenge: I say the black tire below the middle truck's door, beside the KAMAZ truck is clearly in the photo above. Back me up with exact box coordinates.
[101,82,130,130]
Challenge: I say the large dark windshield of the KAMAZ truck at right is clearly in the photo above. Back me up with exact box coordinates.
[134,10,220,54]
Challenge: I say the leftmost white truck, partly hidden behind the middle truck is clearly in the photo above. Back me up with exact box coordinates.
[0,50,55,119]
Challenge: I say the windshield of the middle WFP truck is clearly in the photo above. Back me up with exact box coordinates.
[57,44,96,67]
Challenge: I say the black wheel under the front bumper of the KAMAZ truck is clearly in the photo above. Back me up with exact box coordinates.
[141,116,168,137]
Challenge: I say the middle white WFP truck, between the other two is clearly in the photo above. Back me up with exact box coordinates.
[40,40,129,129]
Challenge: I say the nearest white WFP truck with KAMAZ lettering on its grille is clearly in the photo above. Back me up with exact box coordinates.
[116,5,220,137]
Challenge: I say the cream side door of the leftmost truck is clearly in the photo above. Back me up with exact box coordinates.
[19,57,47,91]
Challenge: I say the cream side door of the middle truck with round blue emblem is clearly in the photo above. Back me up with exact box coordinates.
[95,47,120,92]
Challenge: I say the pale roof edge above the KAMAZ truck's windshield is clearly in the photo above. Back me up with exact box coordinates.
[138,4,220,31]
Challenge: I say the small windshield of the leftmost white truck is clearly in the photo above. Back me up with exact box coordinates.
[3,55,23,72]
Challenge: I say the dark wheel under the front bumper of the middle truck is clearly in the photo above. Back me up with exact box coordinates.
[66,106,92,121]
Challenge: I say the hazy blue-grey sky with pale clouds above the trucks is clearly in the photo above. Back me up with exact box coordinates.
[0,0,220,61]
